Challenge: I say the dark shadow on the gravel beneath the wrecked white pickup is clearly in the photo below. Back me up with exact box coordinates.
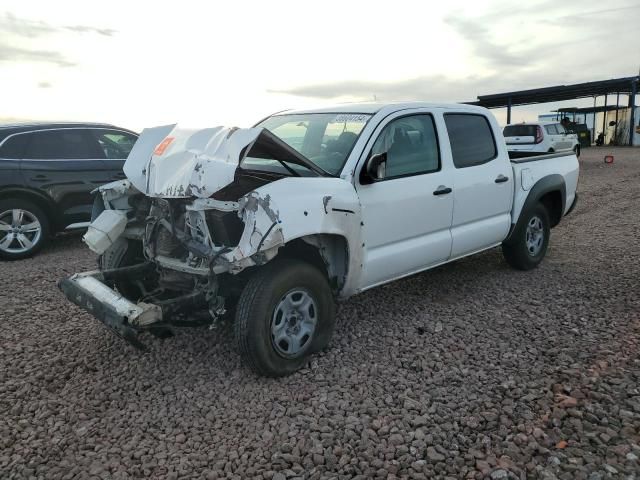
[89,250,517,383]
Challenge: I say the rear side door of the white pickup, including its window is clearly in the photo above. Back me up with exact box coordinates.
[444,113,514,258]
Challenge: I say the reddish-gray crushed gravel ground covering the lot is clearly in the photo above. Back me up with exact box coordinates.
[0,148,640,480]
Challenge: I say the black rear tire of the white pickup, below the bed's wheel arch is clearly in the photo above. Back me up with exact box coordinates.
[502,203,551,270]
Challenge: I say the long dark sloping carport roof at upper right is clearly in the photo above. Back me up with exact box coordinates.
[469,76,640,108]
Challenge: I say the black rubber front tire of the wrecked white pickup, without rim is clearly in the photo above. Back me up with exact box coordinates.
[235,259,335,377]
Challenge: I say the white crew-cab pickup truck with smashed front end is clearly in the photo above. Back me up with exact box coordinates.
[60,103,578,376]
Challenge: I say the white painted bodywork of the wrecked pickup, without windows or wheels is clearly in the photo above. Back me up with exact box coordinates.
[82,103,578,297]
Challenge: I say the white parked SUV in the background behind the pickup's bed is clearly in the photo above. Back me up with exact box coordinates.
[502,122,580,157]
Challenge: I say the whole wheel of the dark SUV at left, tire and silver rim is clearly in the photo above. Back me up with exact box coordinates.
[0,199,50,260]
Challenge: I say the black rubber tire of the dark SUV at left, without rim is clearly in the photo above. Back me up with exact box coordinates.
[0,198,51,260]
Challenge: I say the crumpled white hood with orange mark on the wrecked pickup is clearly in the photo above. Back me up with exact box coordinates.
[124,125,263,198]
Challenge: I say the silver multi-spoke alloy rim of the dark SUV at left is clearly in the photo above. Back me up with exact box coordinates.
[0,208,42,254]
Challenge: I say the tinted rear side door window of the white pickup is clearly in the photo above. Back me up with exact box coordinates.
[444,113,498,168]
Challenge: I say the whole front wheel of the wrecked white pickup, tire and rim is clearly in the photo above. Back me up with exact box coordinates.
[235,259,335,377]
